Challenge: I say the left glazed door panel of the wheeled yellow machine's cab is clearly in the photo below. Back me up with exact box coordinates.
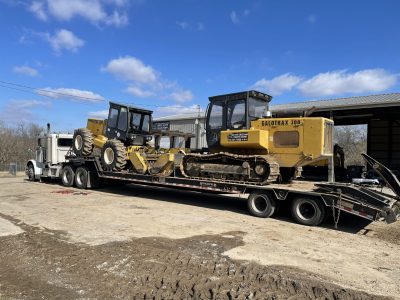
[106,105,128,141]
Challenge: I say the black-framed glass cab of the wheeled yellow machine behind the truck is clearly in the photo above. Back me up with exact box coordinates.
[105,102,153,146]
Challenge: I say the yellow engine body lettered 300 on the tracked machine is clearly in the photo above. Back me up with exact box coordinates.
[221,117,333,167]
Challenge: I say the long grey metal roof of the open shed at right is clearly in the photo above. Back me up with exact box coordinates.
[270,93,400,113]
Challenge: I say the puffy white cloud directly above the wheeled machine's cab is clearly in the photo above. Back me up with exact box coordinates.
[102,56,157,84]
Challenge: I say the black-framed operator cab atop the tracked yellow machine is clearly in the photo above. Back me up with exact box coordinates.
[206,90,272,149]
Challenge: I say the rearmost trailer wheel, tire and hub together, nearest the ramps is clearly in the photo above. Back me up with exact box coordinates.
[291,198,326,226]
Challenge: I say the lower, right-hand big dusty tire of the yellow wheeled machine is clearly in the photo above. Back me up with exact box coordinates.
[101,139,126,171]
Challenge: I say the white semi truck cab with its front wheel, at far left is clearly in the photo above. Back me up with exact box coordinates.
[26,133,72,181]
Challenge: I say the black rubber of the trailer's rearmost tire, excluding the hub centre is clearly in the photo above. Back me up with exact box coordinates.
[291,197,326,226]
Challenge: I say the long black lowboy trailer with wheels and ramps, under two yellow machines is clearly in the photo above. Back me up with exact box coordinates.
[56,156,400,226]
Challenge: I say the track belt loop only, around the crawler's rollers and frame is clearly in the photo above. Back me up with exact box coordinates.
[180,152,280,185]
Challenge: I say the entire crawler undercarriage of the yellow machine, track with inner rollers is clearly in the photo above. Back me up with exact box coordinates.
[181,152,280,185]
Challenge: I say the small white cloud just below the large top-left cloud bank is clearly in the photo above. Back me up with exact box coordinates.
[42,29,85,53]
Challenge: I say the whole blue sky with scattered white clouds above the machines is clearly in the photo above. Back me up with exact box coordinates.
[0,0,400,131]
